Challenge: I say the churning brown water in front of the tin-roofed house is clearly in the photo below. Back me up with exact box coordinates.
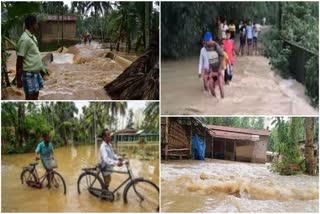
[161,160,319,212]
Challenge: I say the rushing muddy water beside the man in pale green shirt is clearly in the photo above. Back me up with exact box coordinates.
[2,42,137,100]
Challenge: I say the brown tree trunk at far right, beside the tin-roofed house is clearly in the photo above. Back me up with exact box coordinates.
[304,117,316,175]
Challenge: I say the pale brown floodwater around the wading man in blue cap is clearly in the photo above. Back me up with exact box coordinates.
[161,56,318,115]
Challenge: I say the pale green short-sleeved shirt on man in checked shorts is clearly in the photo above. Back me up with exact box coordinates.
[17,30,43,73]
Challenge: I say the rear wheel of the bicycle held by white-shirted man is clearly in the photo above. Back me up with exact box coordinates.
[78,172,104,194]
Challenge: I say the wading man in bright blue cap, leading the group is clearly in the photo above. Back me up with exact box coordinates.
[198,32,224,98]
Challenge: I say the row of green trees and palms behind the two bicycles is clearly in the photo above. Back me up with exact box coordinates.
[1,102,159,153]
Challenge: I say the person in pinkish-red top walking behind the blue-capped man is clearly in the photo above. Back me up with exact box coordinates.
[222,30,235,84]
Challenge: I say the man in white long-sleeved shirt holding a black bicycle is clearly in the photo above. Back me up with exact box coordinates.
[100,129,123,189]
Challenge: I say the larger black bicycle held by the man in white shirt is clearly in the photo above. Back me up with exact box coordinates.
[77,160,159,211]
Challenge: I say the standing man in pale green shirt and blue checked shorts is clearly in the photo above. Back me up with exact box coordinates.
[16,15,43,100]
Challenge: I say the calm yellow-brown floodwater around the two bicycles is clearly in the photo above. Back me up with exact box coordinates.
[1,144,159,212]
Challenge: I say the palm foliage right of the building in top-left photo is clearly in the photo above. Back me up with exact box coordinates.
[71,2,159,51]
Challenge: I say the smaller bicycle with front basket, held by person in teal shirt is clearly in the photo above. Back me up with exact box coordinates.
[20,159,67,195]
